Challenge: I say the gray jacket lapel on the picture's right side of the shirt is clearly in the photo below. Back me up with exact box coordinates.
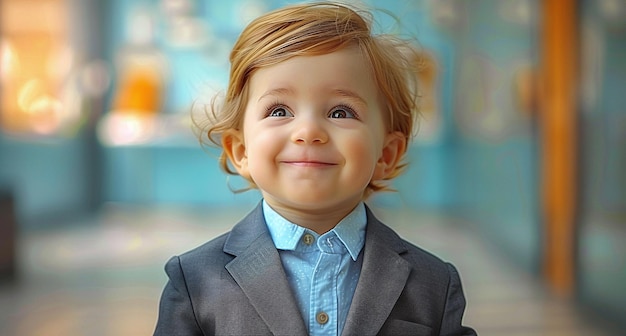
[343,209,411,335]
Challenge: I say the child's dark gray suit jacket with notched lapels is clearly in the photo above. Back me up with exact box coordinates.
[154,206,475,336]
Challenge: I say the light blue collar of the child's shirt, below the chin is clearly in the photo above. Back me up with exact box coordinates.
[263,201,367,260]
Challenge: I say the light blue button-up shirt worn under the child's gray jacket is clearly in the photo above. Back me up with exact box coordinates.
[263,201,367,335]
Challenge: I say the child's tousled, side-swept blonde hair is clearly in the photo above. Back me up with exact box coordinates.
[194,2,418,197]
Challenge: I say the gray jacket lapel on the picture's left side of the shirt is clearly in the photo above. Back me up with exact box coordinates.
[224,206,307,335]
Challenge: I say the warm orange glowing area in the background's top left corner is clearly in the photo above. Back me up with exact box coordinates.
[0,0,81,135]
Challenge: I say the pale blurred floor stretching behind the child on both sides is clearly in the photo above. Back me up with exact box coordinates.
[0,205,619,336]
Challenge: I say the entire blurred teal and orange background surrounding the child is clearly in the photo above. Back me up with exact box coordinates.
[0,0,626,335]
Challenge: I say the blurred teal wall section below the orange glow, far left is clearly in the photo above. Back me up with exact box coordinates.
[0,133,96,228]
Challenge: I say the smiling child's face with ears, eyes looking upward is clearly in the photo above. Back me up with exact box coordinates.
[224,48,401,211]
